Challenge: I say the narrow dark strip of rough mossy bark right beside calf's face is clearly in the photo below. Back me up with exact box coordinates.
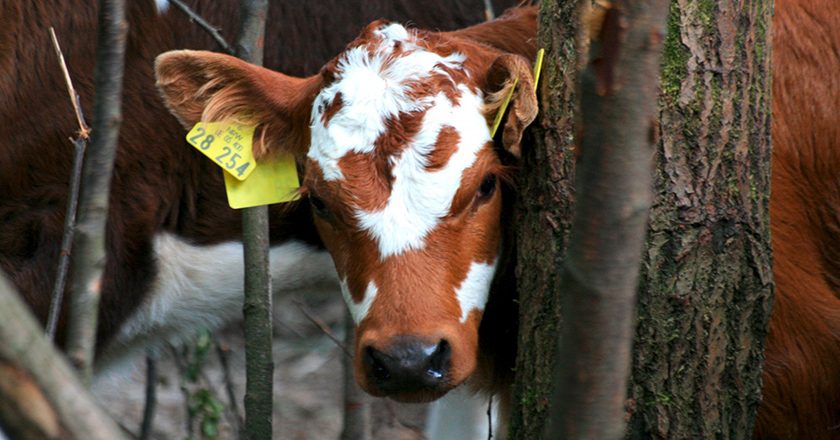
[510,0,579,439]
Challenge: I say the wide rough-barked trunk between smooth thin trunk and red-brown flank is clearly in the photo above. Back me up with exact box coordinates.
[628,0,773,439]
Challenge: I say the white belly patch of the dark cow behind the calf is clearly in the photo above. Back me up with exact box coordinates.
[97,234,337,372]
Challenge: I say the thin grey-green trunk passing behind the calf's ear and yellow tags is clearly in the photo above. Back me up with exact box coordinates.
[235,0,274,440]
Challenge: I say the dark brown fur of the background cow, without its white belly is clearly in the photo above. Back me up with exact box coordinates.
[0,0,510,347]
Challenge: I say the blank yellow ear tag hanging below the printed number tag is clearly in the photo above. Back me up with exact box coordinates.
[225,155,300,209]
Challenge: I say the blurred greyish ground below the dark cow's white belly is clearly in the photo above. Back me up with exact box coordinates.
[94,292,427,440]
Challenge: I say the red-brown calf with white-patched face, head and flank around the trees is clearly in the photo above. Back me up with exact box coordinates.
[156,0,840,439]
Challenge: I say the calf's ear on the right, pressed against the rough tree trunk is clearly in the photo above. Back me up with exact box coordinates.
[485,54,538,158]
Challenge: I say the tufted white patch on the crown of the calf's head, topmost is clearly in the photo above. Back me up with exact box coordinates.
[307,24,464,181]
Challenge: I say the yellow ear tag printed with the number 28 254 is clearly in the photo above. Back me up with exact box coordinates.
[187,122,257,180]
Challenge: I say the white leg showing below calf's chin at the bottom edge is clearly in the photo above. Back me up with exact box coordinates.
[426,385,498,440]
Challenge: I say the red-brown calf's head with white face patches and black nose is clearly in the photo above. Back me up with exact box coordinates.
[156,13,536,401]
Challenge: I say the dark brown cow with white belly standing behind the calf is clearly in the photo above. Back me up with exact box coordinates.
[0,0,513,371]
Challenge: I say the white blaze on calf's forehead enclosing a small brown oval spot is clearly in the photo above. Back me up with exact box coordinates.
[356,85,491,259]
